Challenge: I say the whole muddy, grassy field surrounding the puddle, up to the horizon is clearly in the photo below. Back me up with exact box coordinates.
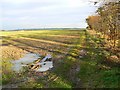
[0,30,120,88]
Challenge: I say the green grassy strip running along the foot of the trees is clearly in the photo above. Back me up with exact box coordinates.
[78,31,120,88]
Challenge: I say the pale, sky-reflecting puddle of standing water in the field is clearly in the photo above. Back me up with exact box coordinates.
[12,53,53,72]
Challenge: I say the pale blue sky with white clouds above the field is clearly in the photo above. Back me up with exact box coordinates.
[0,0,96,30]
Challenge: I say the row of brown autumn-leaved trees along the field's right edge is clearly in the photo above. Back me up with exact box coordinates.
[86,0,120,49]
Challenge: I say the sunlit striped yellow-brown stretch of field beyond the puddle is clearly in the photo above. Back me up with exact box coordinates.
[1,30,81,54]
